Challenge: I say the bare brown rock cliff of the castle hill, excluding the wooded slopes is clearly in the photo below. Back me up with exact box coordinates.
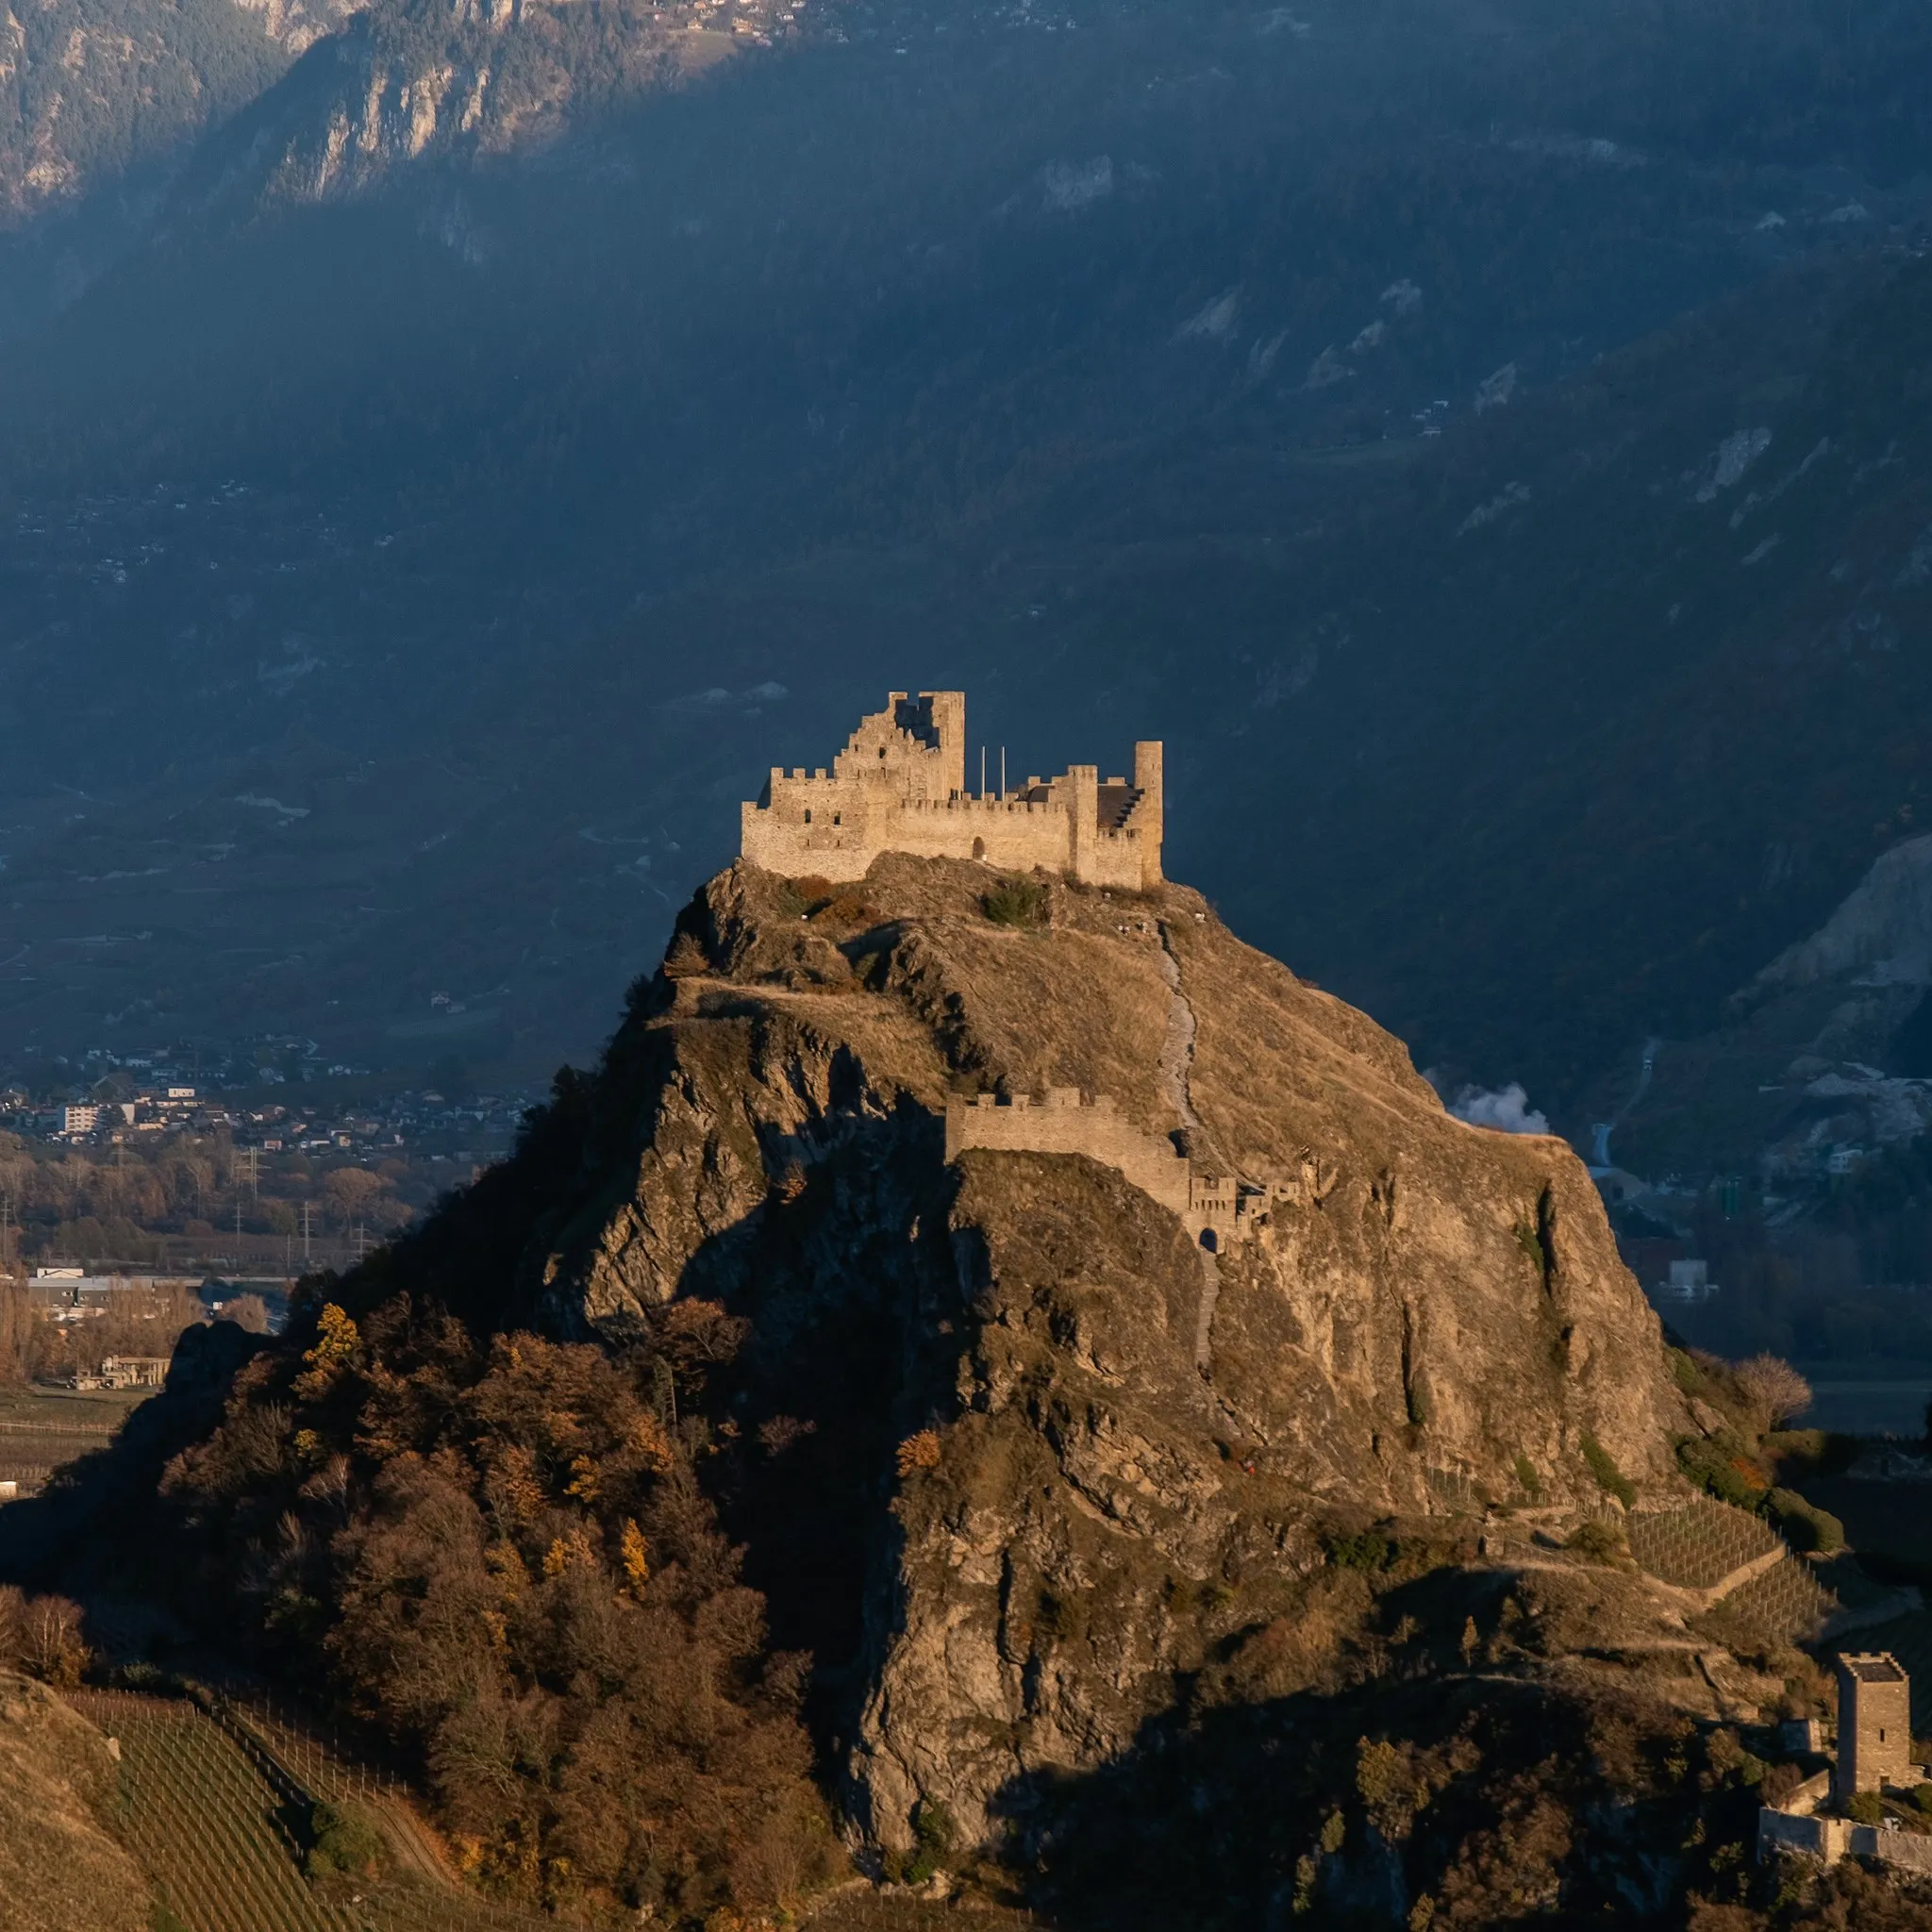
[524,856,1689,1843]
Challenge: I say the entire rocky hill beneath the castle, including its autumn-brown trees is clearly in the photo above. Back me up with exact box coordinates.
[0,850,1897,1932]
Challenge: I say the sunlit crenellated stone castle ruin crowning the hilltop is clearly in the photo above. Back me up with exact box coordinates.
[740,691,1163,891]
